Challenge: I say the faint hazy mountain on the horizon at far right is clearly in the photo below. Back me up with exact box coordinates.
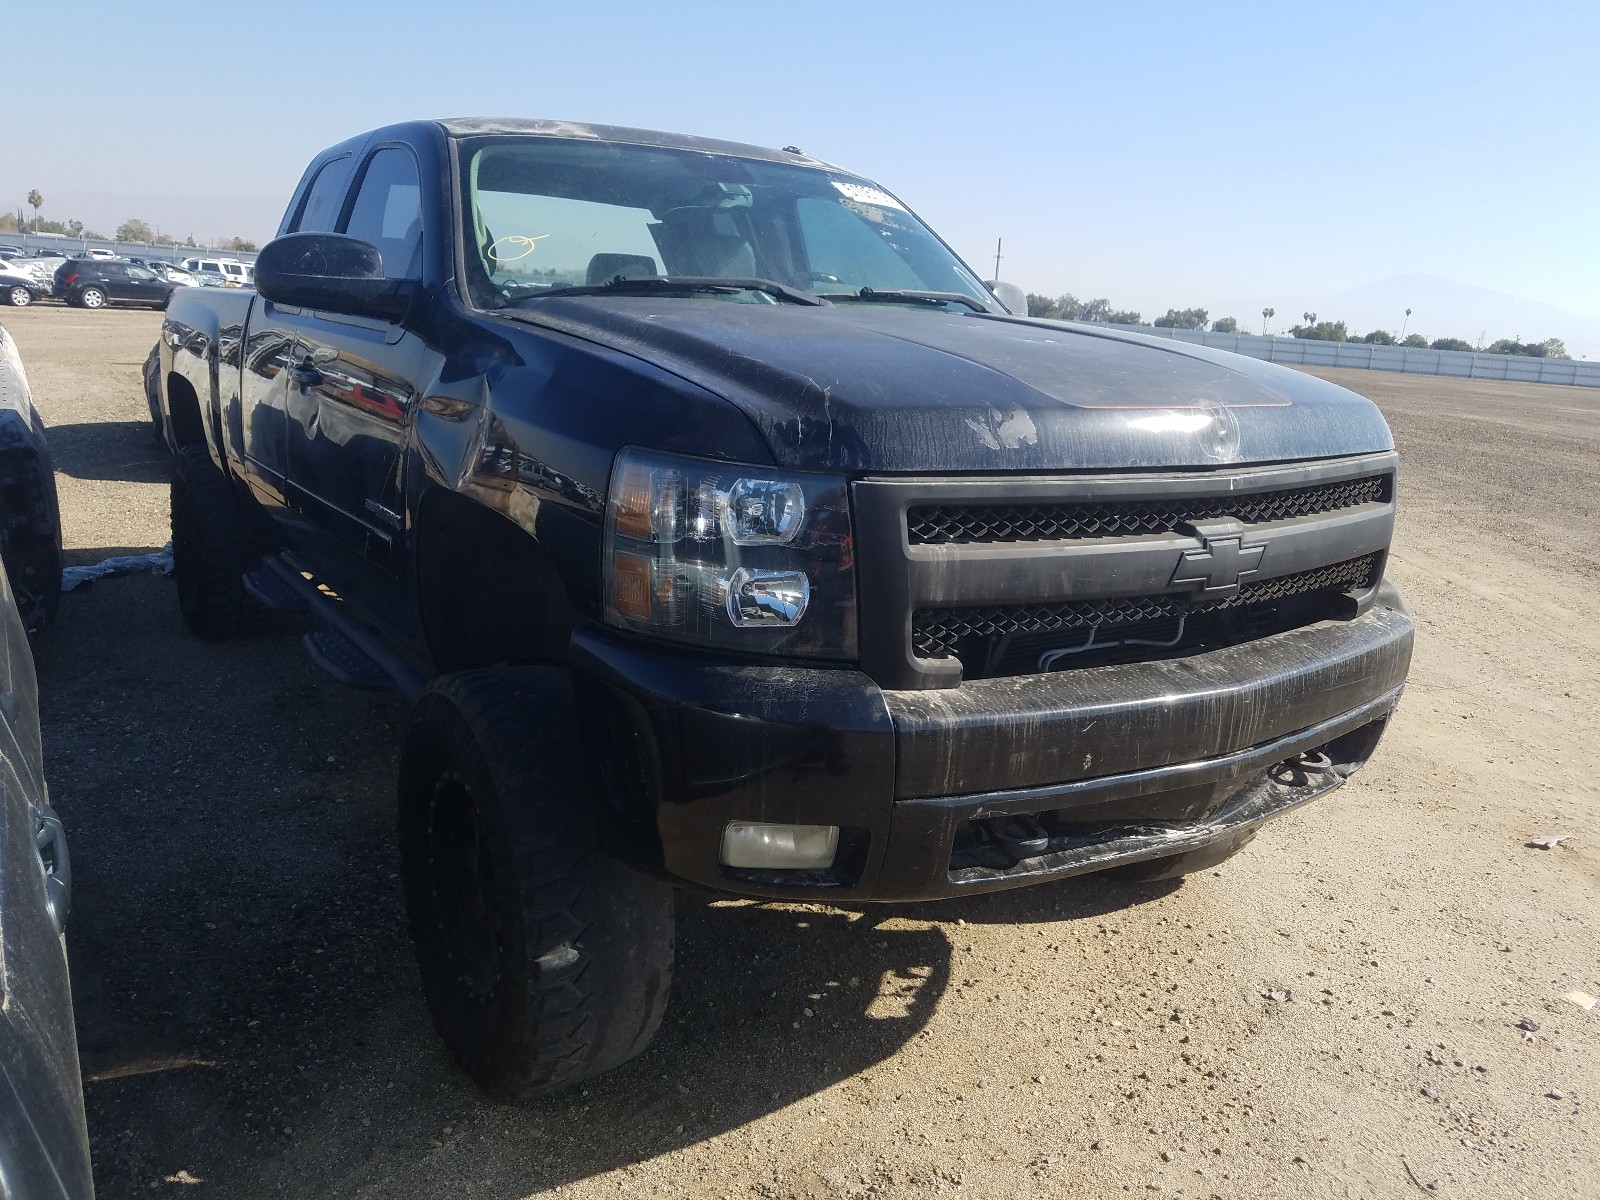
[1260,275,1600,358]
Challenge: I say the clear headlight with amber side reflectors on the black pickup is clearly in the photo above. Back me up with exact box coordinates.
[605,450,856,659]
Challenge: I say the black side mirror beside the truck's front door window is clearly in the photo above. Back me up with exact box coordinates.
[256,234,416,322]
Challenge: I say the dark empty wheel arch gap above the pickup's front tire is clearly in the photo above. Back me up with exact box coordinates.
[413,488,573,672]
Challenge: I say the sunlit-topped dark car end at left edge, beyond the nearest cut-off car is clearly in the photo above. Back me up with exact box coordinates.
[0,325,61,633]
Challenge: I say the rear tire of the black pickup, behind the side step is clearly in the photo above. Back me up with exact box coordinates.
[173,446,254,642]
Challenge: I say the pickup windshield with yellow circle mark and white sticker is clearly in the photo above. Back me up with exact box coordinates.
[461,136,998,310]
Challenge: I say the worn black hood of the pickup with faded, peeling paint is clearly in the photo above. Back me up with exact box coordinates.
[501,296,1394,472]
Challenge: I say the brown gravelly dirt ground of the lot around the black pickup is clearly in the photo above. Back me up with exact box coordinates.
[3,306,1600,1200]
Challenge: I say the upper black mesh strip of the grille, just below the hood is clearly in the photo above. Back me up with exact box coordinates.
[906,472,1394,546]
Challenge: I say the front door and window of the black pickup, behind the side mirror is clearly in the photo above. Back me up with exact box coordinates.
[288,146,424,592]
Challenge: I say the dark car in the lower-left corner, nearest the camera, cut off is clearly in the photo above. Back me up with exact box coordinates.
[0,556,94,1200]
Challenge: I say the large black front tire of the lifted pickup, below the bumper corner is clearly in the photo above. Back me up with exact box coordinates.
[398,667,672,1102]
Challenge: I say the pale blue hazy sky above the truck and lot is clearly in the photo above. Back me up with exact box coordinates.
[12,0,1600,320]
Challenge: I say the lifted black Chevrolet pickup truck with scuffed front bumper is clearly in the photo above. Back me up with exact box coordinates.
[150,120,1413,1098]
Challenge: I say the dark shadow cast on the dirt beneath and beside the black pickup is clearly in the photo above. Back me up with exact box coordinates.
[40,576,1173,1200]
